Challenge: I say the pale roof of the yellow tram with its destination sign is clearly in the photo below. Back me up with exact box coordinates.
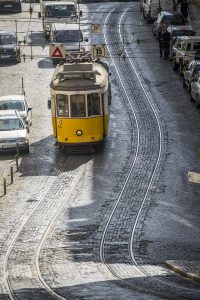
[50,62,108,91]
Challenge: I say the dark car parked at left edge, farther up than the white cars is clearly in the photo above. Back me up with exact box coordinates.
[0,31,21,62]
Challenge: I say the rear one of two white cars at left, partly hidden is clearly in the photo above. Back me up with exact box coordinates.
[0,95,32,126]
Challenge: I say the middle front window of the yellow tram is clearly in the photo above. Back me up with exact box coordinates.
[71,95,86,117]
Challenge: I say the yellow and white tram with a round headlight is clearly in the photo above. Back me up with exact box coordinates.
[49,61,111,148]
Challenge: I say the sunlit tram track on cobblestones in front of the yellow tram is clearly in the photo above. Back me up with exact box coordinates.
[3,156,90,300]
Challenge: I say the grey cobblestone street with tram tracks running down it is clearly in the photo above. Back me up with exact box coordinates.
[0,2,200,300]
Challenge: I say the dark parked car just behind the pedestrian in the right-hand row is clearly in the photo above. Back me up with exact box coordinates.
[152,11,186,37]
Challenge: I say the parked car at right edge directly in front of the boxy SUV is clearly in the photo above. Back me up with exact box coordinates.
[183,60,200,92]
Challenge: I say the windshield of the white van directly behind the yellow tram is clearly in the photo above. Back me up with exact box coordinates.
[55,30,83,43]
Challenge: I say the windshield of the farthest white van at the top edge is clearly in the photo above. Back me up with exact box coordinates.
[45,5,75,18]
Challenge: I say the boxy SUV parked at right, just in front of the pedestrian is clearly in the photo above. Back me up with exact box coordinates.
[172,36,200,75]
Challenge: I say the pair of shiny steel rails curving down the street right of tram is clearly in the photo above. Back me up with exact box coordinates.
[99,4,191,300]
